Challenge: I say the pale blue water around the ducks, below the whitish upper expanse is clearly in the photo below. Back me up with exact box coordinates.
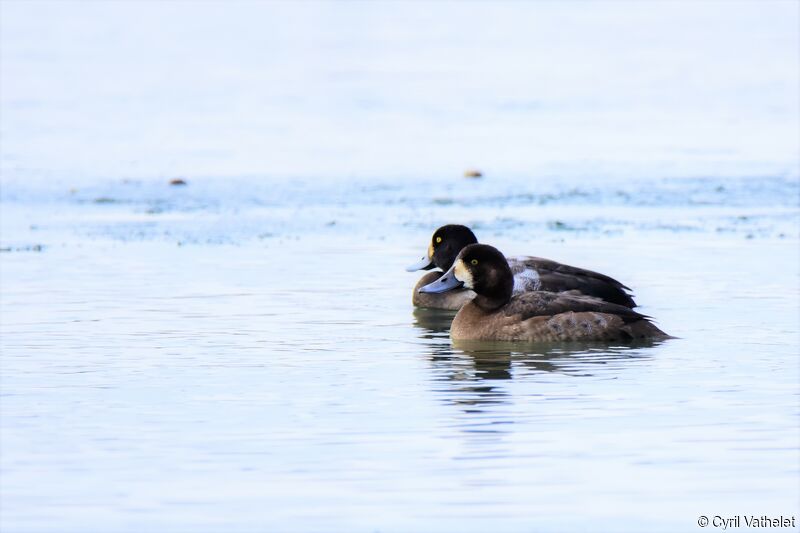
[2,172,800,531]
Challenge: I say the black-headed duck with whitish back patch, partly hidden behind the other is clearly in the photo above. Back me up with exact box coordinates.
[406,224,636,310]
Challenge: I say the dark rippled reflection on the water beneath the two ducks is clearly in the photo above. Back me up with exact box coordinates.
[414,308,658,459]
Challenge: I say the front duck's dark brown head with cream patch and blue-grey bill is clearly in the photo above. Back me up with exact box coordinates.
[419,244,514,309]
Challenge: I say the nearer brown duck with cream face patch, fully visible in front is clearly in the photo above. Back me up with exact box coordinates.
[419,244,670,342]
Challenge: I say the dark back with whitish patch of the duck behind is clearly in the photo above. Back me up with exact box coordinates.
[508,256,636,308]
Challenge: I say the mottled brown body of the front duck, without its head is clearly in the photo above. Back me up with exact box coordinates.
[450,292,669,341]
